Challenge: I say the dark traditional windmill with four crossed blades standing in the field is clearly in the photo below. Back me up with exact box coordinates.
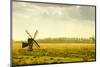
[22,30,40,51]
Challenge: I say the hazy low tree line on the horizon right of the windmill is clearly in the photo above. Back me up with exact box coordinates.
[37,37,95,43]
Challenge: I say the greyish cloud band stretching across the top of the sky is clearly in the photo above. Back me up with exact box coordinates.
[13,2,95,21]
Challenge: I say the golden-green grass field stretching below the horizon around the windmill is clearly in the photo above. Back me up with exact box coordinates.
[12,42,96,65]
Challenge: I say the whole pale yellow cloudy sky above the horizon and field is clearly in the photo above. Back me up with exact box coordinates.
[12,2,95,40]
